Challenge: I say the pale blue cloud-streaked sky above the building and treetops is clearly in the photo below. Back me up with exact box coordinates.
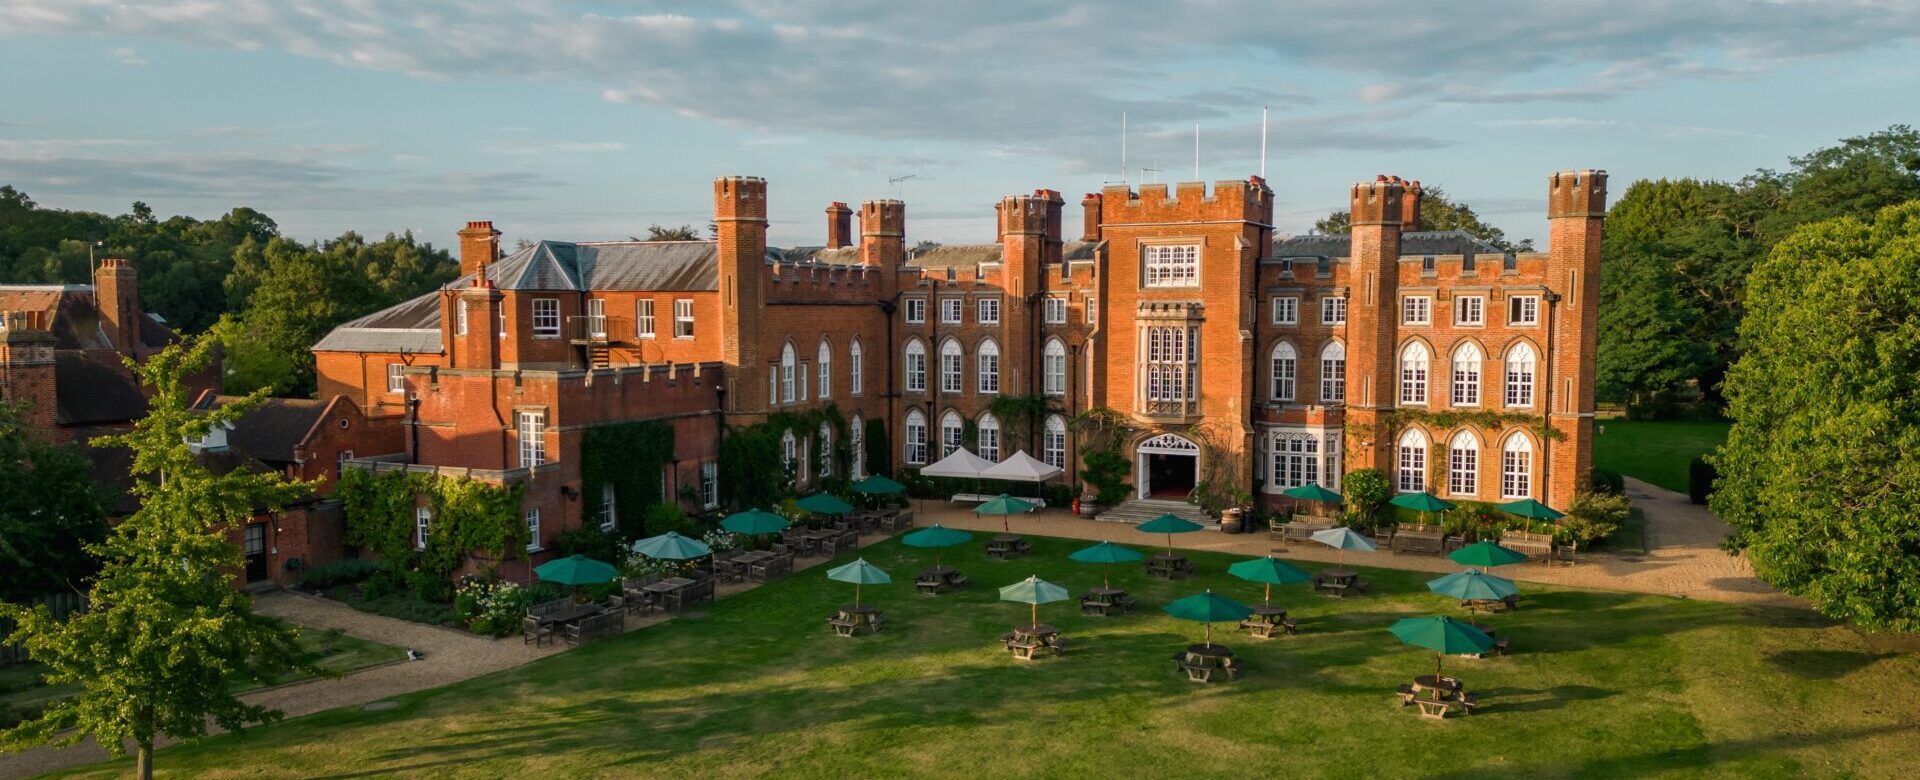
[0,0,1920,244]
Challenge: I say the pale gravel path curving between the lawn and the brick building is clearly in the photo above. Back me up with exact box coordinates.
[0,489,1805,778]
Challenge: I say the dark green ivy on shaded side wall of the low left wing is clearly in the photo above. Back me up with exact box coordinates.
[580,421,674,536]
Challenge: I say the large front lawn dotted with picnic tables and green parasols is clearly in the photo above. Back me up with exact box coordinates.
[45,532,1920,780]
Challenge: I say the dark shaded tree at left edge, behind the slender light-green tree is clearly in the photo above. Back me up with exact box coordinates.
[0,403,108,601]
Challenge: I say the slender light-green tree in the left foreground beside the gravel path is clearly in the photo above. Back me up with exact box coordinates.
[0,336,311,778]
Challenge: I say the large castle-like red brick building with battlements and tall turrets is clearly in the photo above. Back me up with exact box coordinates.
[315,171,1605,559]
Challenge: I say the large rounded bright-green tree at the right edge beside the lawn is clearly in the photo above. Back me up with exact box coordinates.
[1711,202,1920,632]
